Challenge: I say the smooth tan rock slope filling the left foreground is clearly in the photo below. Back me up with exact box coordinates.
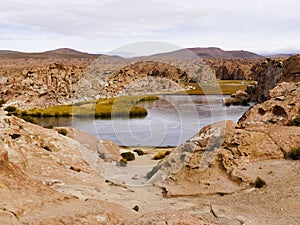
[0,112,138,224]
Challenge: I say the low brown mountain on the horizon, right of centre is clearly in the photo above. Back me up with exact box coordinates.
[154,47,263,59]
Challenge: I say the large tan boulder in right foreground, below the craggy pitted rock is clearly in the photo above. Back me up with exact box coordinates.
[148,118,300,197]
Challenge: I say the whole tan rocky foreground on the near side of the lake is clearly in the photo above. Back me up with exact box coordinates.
[0,52,300,225]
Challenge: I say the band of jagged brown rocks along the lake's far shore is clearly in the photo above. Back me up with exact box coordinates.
[0,49,262,108]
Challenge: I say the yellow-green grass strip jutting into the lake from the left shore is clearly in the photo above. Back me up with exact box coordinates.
[17,96,158,118]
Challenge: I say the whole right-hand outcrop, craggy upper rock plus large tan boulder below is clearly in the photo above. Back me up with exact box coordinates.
[148,83,300,197]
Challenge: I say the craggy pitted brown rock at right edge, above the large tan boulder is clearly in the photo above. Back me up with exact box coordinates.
[239,82,300,127]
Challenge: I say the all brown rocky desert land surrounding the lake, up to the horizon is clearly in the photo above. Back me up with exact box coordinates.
[0,48,300,225]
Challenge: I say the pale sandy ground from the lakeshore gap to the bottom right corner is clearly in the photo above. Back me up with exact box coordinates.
[56,147,300,225]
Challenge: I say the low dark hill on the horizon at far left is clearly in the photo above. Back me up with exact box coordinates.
[0,48,100,59]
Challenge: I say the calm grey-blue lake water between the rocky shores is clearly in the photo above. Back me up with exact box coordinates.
[39,95,253,147]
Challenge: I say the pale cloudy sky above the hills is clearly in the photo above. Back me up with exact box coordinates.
[0,0,300,53]
